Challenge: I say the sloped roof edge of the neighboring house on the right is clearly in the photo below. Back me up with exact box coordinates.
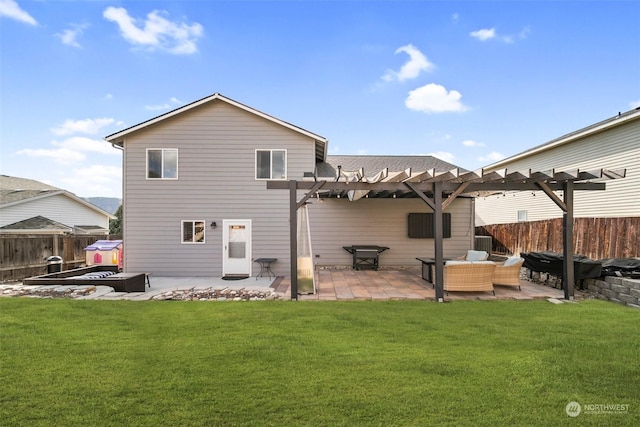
[484,107,640,170]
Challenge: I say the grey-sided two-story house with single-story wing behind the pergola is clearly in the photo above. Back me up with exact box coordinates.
[105,94,474,276]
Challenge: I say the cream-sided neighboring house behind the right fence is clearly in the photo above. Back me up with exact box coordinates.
[476,108,640,226]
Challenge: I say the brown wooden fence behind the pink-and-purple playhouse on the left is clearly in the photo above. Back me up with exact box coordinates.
[0,234,120,282]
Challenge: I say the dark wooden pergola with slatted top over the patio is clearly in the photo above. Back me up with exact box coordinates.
[267,169,626,302]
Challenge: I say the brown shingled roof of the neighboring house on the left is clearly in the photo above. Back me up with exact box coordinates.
[0,175,115,219]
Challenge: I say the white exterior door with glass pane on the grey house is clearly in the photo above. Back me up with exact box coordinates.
[222,219,251,276]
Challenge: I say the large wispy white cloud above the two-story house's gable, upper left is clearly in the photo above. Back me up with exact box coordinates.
[103,7,204,55]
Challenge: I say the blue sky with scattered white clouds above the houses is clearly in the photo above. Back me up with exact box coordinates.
[0,0,640,197]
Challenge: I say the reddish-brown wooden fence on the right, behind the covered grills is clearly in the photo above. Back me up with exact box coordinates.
[476,217,640,259]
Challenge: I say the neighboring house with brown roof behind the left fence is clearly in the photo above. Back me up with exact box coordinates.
[0,175,115,234]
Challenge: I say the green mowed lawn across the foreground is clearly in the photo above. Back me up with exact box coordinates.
[0,298,640,426]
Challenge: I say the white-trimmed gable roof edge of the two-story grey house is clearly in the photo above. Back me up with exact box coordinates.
[104,92,329,159]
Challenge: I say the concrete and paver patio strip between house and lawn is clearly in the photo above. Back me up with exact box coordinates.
[5,268,583,301]
